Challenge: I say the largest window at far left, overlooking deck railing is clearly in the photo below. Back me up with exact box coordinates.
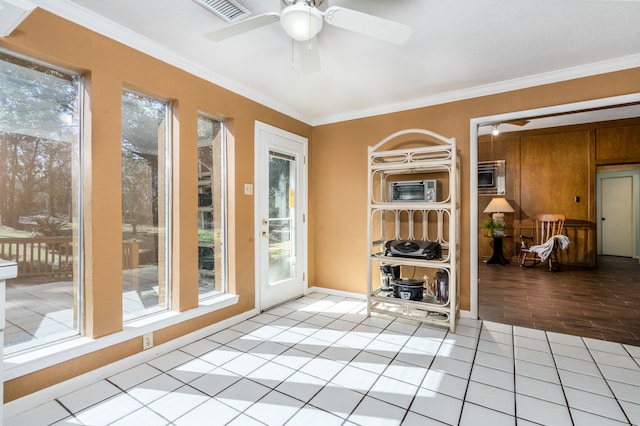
[0,52,82,353]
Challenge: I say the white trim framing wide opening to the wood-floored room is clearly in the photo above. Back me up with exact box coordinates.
[463,93,640,319]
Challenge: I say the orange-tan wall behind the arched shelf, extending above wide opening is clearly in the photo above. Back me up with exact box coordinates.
[309,68,640,309]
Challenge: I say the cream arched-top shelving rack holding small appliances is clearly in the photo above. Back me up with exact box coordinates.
[367,129,460,332]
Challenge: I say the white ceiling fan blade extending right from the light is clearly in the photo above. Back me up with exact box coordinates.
[324,6,413,44]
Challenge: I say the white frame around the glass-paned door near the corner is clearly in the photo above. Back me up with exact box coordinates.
[253,120,309,312]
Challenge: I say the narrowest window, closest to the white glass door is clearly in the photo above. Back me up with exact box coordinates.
[198,114,227,300]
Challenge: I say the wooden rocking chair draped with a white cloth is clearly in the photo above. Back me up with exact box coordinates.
[518,214,569,271]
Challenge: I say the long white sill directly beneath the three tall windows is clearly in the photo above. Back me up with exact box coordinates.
[3,294,239,381]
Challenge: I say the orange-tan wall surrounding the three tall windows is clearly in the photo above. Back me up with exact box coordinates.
[0,9,311,401]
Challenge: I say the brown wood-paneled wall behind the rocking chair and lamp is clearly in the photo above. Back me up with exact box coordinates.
[478,118,640,267]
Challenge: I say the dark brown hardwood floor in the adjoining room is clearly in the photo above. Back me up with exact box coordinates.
[478,256,640,346]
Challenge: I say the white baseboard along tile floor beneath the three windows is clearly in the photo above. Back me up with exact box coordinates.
[0,309,260,424]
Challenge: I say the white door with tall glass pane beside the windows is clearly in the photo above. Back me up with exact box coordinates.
[255,122,307,310]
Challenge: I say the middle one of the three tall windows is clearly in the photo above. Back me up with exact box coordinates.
[122,90,170,321]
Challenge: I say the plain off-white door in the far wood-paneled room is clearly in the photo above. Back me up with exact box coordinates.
[599,176,635,257]
